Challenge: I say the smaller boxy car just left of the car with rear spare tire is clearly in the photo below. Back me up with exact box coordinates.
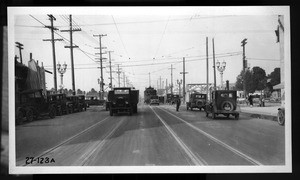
[186,92,207,111]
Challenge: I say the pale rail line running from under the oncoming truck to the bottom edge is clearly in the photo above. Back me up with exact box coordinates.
[79,119,124,166]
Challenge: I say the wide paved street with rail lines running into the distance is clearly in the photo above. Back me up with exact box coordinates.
[16,105,285,166]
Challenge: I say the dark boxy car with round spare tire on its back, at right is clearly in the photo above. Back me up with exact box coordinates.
[205,90,239,119]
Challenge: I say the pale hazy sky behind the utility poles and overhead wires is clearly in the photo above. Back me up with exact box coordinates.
[13,9,280,91]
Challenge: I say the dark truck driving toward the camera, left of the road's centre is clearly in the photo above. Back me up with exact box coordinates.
[107,87,139,116]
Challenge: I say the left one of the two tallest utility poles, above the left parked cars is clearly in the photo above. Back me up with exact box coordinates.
[43,14,63,92]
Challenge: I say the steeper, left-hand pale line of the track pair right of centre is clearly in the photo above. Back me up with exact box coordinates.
[150,106,207,166]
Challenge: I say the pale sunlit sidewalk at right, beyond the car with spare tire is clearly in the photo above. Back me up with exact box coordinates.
[240,105,281,121]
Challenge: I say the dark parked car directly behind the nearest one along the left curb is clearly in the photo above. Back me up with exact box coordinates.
[47,93,73,116]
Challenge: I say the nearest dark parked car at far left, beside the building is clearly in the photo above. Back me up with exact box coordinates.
[16,89,56,124]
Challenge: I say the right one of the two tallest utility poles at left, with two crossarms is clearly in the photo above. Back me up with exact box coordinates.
[61,15,81,95]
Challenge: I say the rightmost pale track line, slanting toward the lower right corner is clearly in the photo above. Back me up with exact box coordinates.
[159,108,263,165]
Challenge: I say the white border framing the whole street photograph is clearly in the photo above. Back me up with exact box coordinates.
[8,6,292,174]
